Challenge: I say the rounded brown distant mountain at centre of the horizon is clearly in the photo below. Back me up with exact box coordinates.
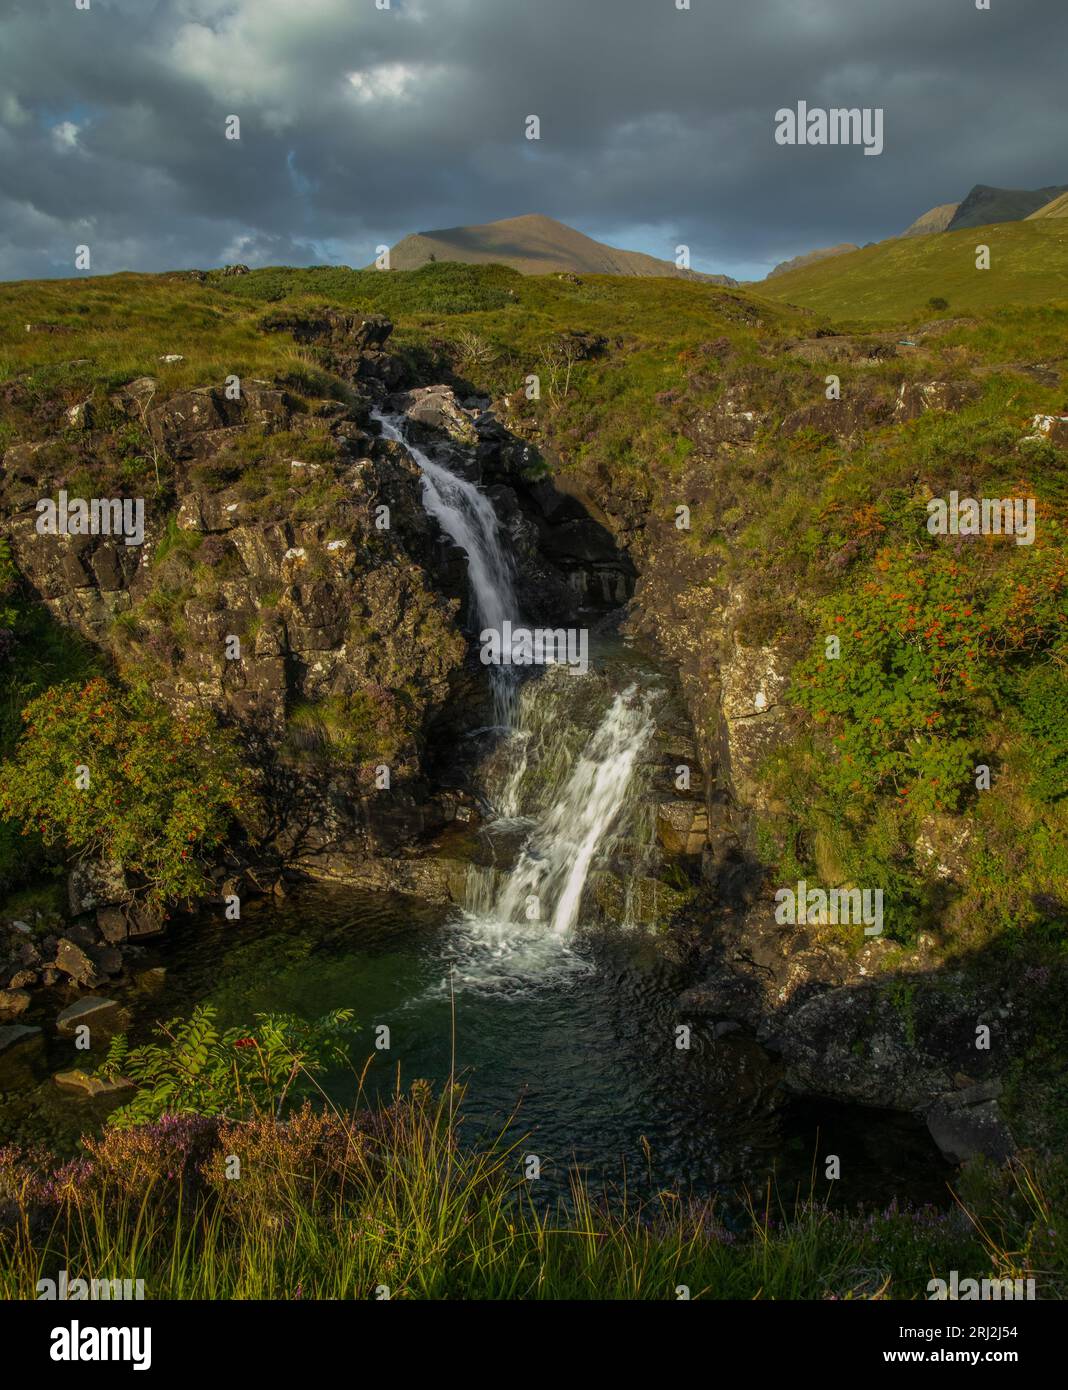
[378,213,737,285]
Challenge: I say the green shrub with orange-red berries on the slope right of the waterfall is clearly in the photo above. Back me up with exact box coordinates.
[794,536,1065,810]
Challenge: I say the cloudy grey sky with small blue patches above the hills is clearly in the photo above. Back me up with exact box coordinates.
[0,0,1068,279]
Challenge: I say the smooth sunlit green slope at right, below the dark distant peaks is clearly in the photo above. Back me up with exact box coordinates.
[761,218,1068,321]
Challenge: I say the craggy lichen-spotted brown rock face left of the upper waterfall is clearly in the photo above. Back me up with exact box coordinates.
[0,322,474,878]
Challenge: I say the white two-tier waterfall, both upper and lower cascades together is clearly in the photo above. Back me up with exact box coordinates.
[375,411,658,991]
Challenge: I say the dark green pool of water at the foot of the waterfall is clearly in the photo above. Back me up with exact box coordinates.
[0,887,948,1202]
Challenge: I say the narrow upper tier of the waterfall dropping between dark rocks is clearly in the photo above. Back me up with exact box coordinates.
[371,410,520,727]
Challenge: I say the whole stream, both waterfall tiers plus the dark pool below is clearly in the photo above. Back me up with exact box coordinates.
[0,416,948,1204]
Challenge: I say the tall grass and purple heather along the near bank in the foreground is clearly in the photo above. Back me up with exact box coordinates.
[0,1084,1068,1300]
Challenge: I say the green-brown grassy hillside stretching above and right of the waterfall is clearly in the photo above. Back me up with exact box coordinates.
[0,261,1068,967]
